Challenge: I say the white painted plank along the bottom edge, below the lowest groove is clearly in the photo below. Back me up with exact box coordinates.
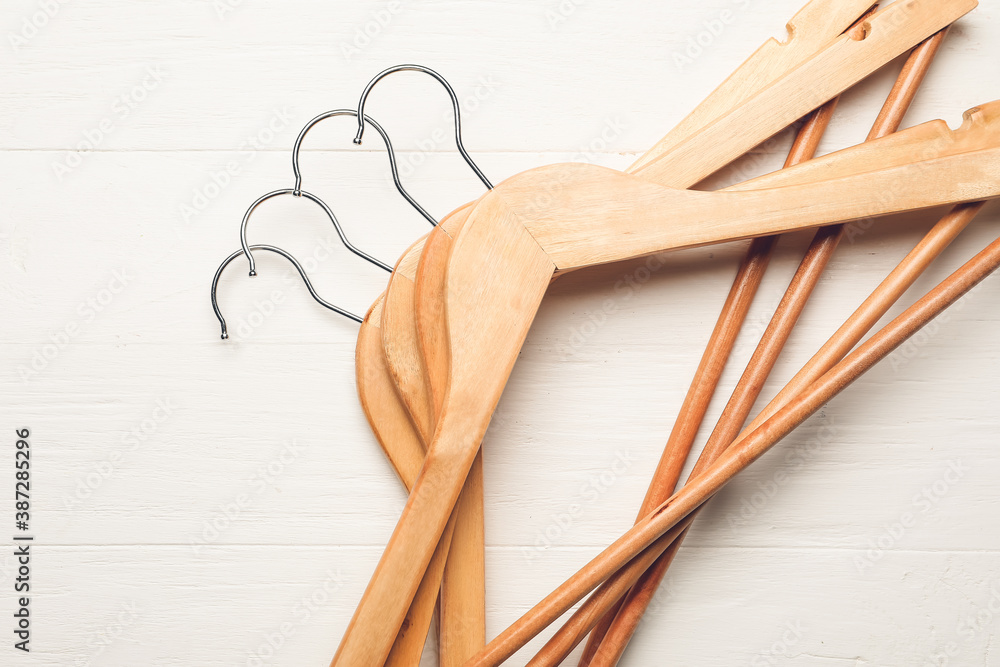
[3,546,1000,667]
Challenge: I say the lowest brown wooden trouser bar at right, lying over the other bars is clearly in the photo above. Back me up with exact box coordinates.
[468,227,1000,667]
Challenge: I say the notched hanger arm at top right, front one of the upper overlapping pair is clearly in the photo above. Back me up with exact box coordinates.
[635,0,977,187]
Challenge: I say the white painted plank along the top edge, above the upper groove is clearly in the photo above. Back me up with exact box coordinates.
[0,0,1000,151]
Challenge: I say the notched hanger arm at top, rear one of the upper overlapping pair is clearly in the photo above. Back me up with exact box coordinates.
[629,0,873,171]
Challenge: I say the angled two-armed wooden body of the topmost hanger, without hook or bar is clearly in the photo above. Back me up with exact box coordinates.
[334,102,1000,664]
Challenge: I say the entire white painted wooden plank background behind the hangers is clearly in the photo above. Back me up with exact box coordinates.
[0,0,1000,667]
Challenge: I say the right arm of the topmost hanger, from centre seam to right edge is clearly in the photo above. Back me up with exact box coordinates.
[512,142,1000,270]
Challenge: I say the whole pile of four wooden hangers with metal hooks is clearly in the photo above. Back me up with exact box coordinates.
[212,0,1000,667]
